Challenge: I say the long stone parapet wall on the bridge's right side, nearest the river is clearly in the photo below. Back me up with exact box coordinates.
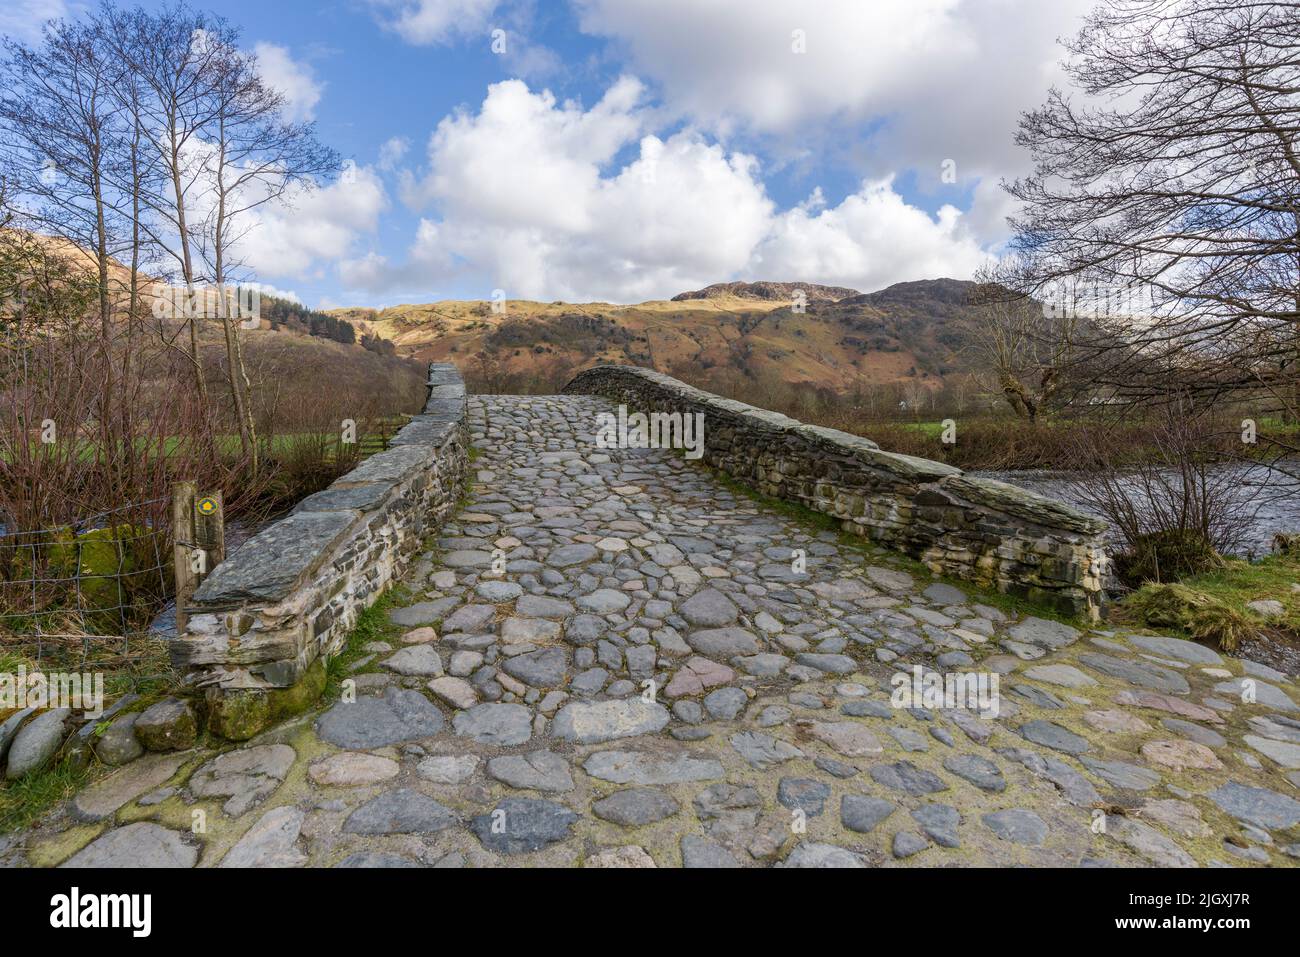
[564,365,1106,618]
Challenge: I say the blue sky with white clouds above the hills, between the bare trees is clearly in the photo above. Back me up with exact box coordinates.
[0,0,1087,307]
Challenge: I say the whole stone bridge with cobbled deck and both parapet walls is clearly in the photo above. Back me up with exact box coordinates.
[0,365,1300,867]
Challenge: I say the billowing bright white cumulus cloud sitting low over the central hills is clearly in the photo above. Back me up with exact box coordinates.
[341,77,985,302]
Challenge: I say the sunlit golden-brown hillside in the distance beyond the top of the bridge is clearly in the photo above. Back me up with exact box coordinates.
[330,280,972,393]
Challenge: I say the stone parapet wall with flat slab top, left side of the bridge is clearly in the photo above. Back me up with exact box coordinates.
[172,363,468,737]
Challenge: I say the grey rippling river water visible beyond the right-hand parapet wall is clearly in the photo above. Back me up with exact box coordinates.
[969,462,1300,558]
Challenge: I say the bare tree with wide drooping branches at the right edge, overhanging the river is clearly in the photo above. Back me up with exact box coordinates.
[1008,0,1300,436]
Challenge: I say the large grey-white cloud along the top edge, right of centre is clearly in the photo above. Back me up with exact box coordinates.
[573,0,1095,241]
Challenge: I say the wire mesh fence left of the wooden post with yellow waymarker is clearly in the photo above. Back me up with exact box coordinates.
[0,498,173,667]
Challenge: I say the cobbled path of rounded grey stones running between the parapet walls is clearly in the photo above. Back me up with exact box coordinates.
[5,397,1300,867]
